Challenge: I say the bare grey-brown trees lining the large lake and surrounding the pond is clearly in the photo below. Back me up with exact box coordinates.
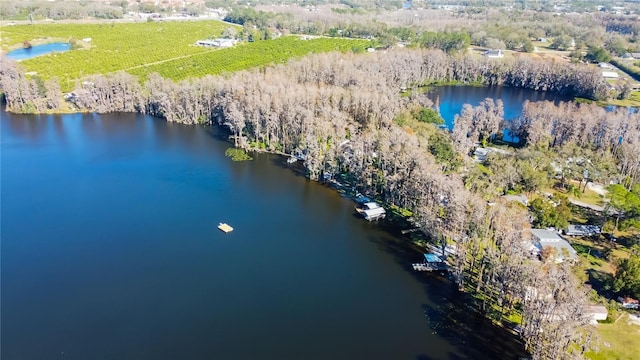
[5,45,640,359]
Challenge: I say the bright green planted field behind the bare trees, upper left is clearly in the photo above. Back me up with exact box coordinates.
[1,21,368,91]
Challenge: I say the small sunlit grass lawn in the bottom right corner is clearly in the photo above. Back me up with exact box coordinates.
[586,314,640,360]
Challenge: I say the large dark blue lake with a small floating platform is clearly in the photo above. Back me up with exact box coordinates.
[0,105,521,360]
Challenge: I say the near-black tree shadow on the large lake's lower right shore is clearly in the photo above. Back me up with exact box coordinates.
[370,226,527,360]
